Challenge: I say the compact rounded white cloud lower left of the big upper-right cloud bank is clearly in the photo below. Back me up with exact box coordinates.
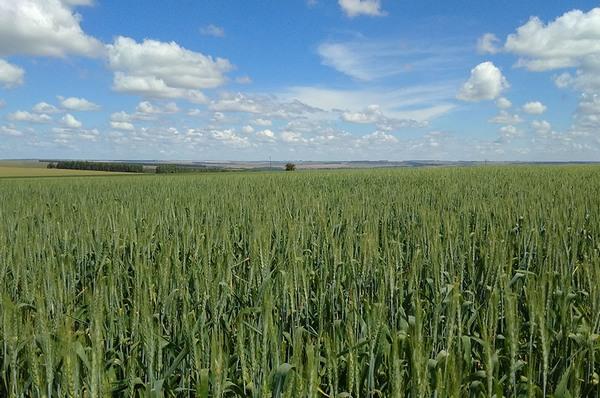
[457,61,509,102]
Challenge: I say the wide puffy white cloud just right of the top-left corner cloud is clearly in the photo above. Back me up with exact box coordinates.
[107,36,233,103]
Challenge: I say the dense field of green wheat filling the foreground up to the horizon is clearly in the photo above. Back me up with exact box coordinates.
[0,166,600,398]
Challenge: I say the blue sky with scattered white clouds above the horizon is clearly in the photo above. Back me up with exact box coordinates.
[0,0,600,160]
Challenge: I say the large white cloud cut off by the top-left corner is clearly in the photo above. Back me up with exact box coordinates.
[0,0,103,57]
